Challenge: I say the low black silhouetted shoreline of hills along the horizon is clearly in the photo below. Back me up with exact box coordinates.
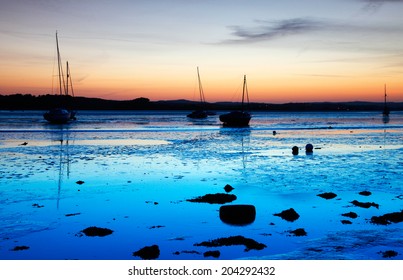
[0,94,403,112]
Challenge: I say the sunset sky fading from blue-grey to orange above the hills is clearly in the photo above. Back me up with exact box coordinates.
[0,0,403,103]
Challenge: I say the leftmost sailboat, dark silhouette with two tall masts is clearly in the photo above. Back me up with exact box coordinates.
[43,32,76,124]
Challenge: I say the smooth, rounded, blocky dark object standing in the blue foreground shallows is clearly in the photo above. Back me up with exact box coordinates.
[220,204,256,226]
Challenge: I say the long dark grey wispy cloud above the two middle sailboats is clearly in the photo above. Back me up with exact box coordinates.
[226,18,325,43]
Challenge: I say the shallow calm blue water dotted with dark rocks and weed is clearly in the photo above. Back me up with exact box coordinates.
[0,111,403,260]
